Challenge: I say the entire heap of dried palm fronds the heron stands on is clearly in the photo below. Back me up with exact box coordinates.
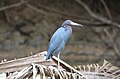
[0,51,120,79]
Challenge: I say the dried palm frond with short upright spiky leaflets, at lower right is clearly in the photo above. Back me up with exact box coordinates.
[74,60,120,79]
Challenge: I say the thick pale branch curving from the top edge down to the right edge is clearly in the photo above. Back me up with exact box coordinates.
[75,0,120,28]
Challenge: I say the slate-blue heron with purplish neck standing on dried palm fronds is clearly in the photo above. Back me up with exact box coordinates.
[46,20,82,67]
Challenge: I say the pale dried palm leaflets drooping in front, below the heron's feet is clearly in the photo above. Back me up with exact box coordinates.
[6,64,86,79]
